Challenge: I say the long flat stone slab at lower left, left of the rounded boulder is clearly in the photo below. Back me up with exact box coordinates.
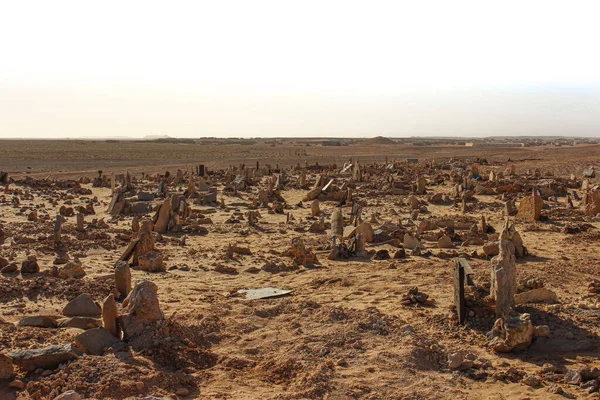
[8,344,81,371]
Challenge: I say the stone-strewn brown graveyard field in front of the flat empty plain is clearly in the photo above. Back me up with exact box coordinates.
[0,145,600,400]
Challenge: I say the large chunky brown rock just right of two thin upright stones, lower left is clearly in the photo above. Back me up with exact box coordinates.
[119,280,164,340]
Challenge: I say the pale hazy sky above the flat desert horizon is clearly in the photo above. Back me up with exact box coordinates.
[0,0,600,137]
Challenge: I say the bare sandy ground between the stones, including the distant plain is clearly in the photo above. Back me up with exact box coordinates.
[0,141,600,399]
